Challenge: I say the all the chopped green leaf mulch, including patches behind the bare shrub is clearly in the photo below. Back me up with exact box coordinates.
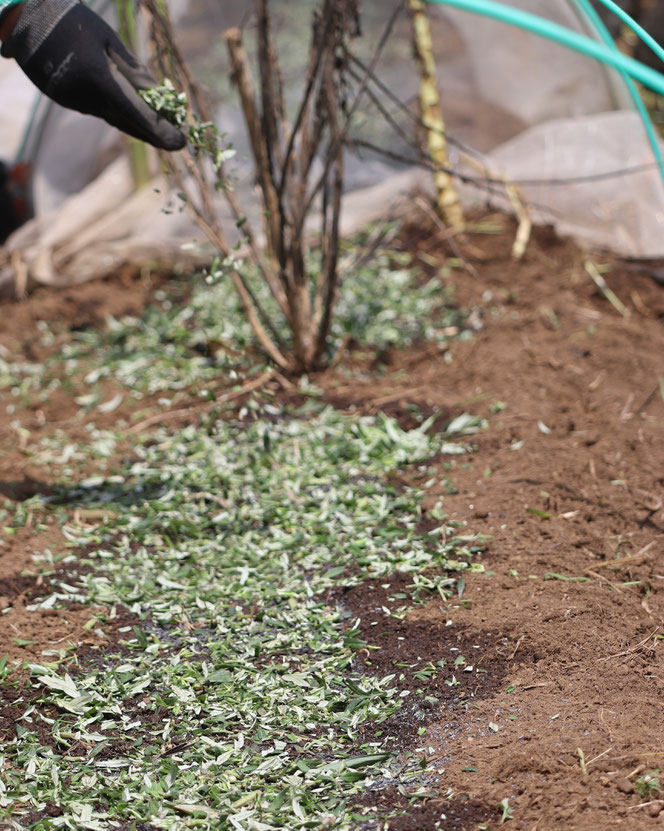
[0,231,481,831]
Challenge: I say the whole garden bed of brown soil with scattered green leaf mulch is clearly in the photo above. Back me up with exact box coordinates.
[0,215,664,831]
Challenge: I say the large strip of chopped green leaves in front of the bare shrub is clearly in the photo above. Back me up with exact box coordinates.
[0,405,486,830]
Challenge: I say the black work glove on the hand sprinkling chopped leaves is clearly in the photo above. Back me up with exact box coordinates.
[1,0,186,150]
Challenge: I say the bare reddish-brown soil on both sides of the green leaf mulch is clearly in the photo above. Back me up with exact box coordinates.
[0,211,664,831]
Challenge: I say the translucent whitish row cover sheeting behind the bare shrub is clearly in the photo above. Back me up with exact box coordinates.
[0,0,664,296]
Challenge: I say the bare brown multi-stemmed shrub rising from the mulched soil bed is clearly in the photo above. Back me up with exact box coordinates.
[143,0,378,371]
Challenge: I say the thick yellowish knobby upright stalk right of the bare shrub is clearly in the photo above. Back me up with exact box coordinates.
[408,0,466,232]
